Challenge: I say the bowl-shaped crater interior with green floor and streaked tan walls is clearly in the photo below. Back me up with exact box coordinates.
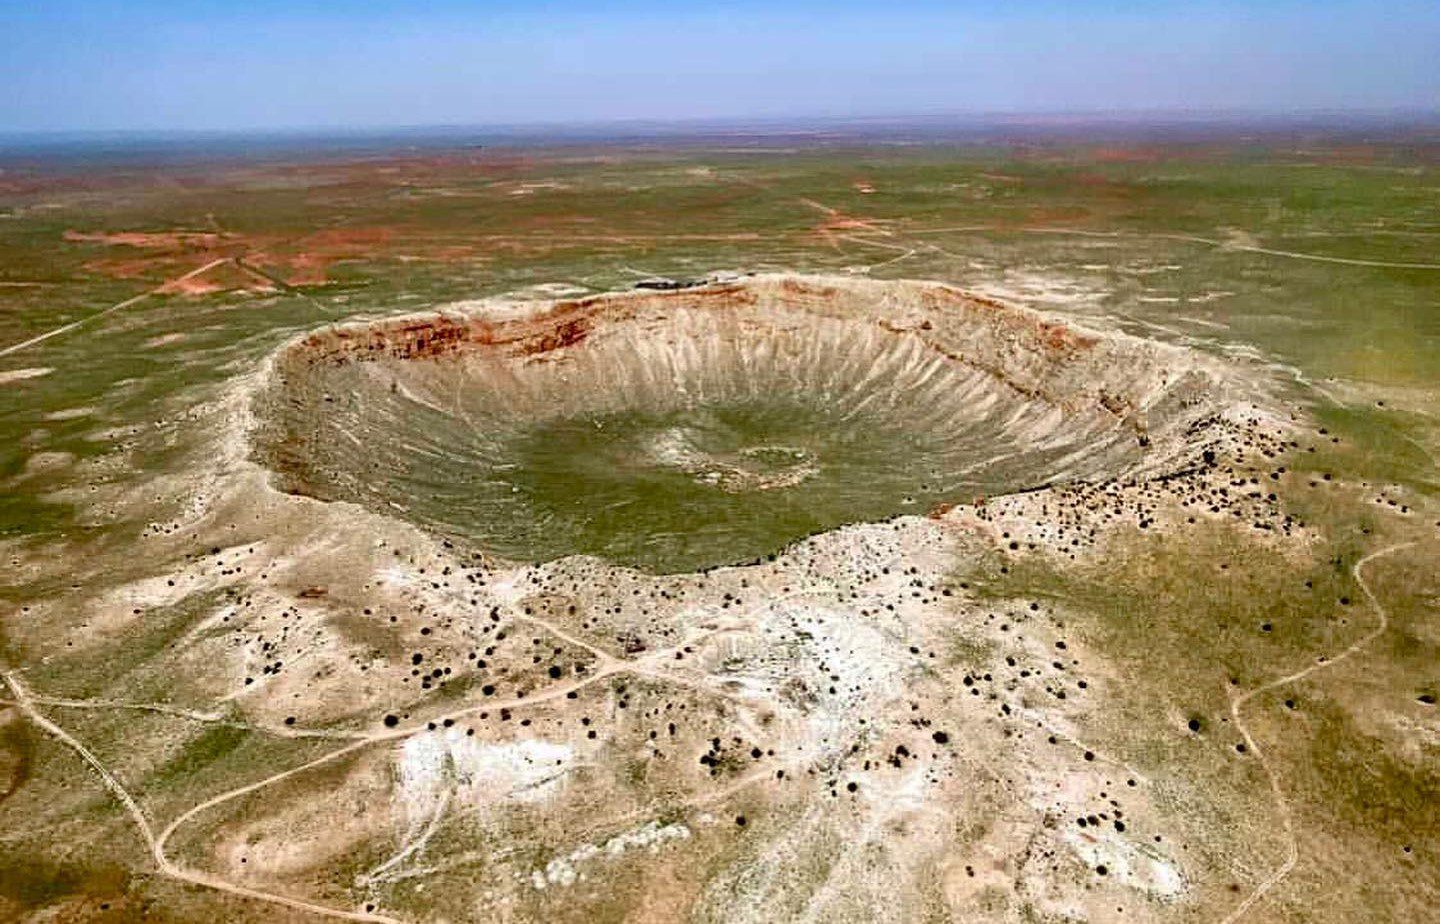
[252,276,1217,571]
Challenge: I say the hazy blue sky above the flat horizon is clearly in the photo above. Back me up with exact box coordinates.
[0,0,1440,131]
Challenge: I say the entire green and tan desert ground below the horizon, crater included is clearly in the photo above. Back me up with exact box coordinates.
[0,123,1440,924]
